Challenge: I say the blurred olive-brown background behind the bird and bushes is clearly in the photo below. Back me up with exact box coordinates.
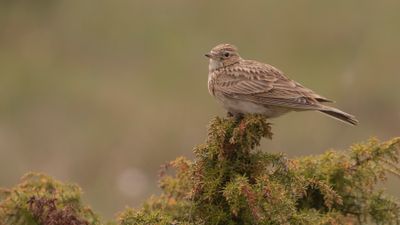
[0,0,400,218]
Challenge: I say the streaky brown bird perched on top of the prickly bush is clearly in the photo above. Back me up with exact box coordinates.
[205,44,358,125]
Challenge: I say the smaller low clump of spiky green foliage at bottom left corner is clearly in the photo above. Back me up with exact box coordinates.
[0,173,100,225]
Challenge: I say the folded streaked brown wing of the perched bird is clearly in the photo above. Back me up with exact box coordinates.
[214,60,330,109]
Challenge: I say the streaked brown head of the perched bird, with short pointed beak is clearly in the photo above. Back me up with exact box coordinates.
[205,44,241,70]
